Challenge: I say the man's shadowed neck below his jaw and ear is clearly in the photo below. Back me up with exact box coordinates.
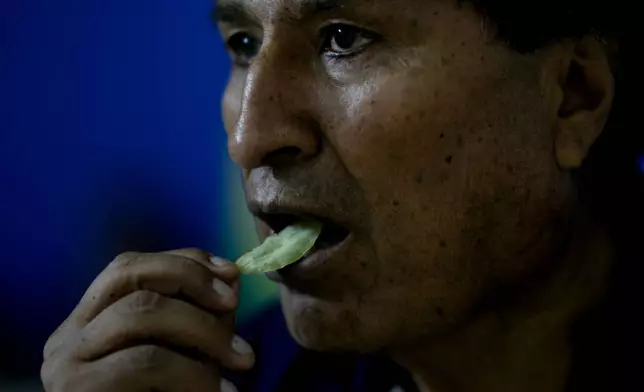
[393,213,612,392]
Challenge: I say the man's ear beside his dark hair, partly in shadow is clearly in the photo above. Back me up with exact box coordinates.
[554,37,615,170]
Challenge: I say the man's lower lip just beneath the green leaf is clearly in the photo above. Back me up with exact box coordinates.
[266,234,353,283]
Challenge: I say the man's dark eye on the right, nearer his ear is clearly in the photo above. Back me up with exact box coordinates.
[322,23,376,57]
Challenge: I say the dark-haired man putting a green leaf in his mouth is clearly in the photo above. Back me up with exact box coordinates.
[42,0,641,392]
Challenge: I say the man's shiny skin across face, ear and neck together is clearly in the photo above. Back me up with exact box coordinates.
[218,0,614,392]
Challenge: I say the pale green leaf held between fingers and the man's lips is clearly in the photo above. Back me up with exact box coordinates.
[237,221,322,274]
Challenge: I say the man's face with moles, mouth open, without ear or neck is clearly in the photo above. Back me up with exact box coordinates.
[218,0,574,351]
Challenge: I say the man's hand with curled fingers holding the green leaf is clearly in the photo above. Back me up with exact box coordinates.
[41,249,254,392]
